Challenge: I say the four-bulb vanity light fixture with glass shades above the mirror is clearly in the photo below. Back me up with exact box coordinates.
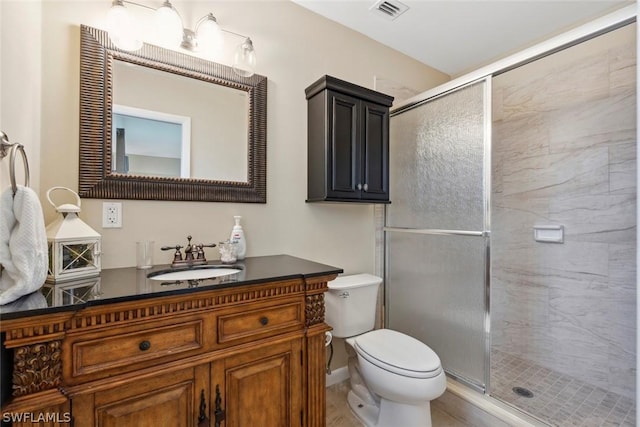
[107,0,256,77]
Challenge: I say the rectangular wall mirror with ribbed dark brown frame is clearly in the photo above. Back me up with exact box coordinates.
[79,25,267,203]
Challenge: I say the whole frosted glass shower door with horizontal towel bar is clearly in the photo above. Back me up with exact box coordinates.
[384,80,489,390]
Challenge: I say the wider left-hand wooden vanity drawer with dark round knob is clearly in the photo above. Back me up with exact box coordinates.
[68,317,207,383]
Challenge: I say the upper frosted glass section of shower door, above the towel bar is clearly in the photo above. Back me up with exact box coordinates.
[387,82,485,230]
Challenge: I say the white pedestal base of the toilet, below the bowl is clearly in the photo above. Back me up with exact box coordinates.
[347,390,432,427]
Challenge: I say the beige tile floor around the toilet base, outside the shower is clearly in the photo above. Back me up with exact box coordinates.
[327,381,474,427]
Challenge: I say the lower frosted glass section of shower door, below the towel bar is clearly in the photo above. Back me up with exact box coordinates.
[386,232,485,385]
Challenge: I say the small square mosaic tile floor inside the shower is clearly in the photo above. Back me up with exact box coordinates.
[491,350,636,427]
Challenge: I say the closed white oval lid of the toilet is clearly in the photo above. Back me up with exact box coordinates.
[354,329,442,378]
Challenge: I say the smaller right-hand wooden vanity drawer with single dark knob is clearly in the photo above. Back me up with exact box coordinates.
[217,300,304,344]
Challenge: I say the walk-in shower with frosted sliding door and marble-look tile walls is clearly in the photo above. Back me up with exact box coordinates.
[384,24,637,426]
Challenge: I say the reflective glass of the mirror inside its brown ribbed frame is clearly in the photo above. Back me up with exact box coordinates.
[112,60,249,182]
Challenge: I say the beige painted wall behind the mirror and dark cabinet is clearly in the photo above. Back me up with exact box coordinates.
[0,0,448,273]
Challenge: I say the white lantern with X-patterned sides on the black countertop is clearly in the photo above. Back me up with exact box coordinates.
[47,187,101,282]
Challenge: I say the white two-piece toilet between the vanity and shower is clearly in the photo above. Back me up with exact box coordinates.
[325,274,447,427]
